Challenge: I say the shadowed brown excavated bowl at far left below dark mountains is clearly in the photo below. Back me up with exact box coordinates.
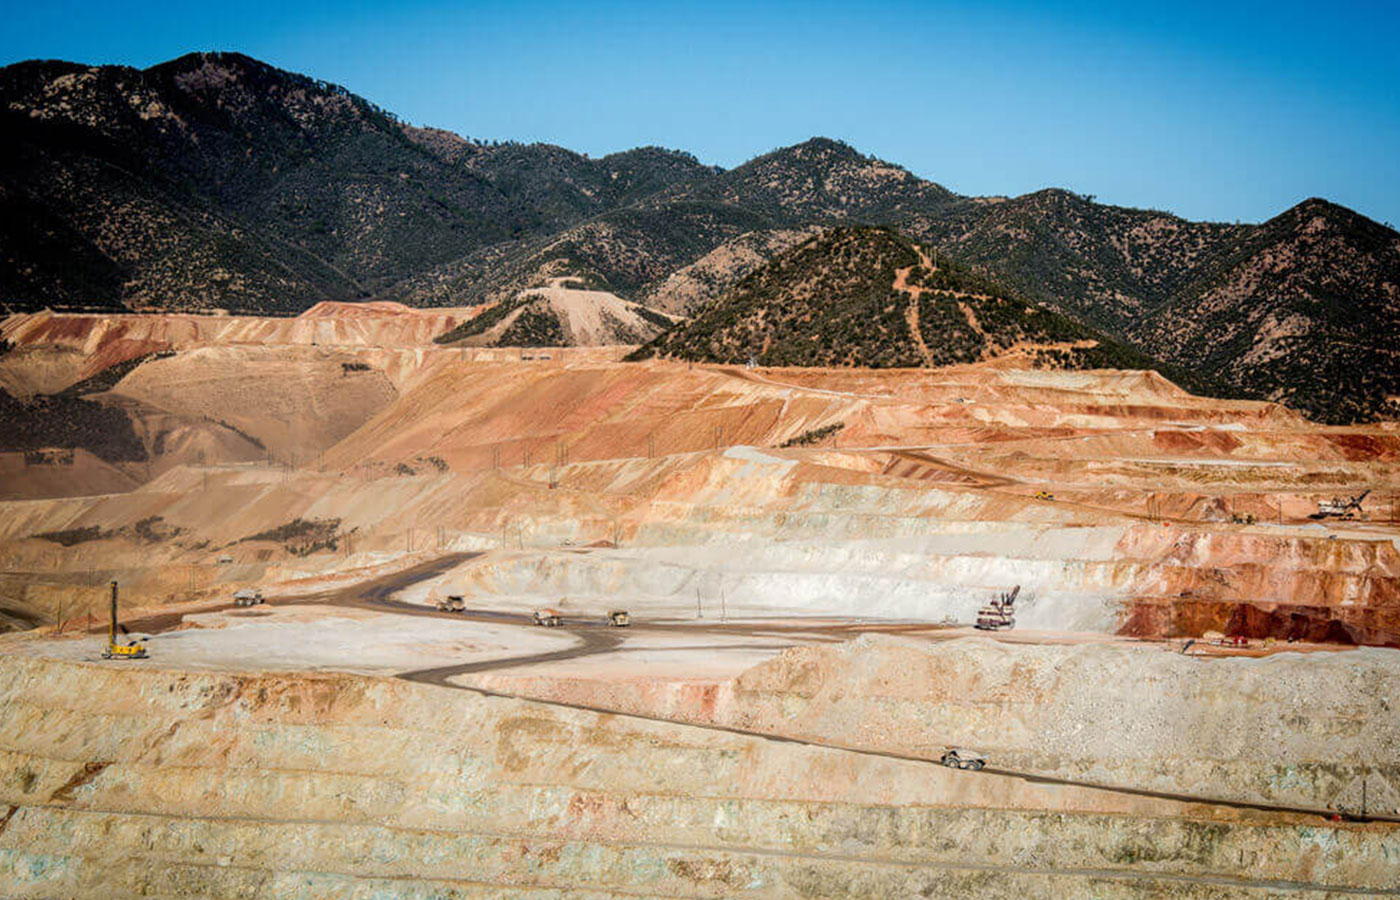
[0,302,477,478]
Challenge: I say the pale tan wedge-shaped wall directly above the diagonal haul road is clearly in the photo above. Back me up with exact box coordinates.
[470,634,1400,815]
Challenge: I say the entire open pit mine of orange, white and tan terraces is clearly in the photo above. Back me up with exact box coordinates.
[0,304,1400,900]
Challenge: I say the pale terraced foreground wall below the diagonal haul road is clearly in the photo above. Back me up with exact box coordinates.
[0,658,1400,900]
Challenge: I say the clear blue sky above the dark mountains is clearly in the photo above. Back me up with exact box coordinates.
[8,0,1400,224]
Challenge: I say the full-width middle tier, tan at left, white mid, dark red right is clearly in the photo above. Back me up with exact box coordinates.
[0,451,1400,644]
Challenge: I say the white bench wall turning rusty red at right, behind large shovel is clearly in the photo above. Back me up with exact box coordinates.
[444,515,1400,644]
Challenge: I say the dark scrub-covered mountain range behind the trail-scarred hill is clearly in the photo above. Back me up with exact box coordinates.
[0,53,1400,421]
